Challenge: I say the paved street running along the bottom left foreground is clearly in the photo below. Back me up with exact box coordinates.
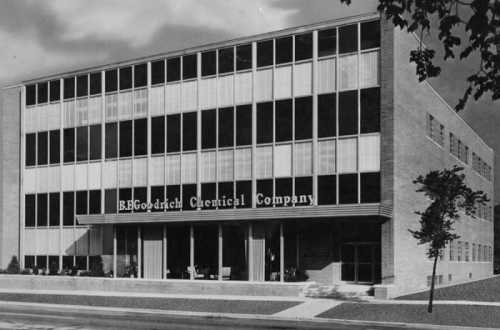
[0,304,432,330]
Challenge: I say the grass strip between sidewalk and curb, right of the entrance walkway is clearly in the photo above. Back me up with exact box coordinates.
[318,303,500,328]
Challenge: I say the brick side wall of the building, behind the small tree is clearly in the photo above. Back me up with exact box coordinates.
[392,29,494,295]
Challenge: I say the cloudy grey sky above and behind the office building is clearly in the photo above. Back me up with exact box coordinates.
[0,0,500,203]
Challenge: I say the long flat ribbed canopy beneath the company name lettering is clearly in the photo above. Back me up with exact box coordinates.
[76,203,392,225]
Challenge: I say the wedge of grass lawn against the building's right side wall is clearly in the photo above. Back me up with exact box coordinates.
[396,276,500,302]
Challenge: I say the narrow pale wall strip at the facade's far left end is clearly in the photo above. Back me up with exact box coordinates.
[0,87,21,268]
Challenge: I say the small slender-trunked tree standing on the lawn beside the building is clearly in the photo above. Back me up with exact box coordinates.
[409,166,488,313]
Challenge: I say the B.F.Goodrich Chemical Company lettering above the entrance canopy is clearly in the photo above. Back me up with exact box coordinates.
[118,193,314,211]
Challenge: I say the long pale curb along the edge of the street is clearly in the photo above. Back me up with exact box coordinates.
[0,301,498,330]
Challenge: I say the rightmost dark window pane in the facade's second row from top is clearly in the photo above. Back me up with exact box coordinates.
[360,87,380,133]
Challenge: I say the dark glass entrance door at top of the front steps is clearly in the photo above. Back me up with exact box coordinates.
[341,242,380,284]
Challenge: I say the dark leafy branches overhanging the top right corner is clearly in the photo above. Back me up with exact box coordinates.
[340,0,500,111]
